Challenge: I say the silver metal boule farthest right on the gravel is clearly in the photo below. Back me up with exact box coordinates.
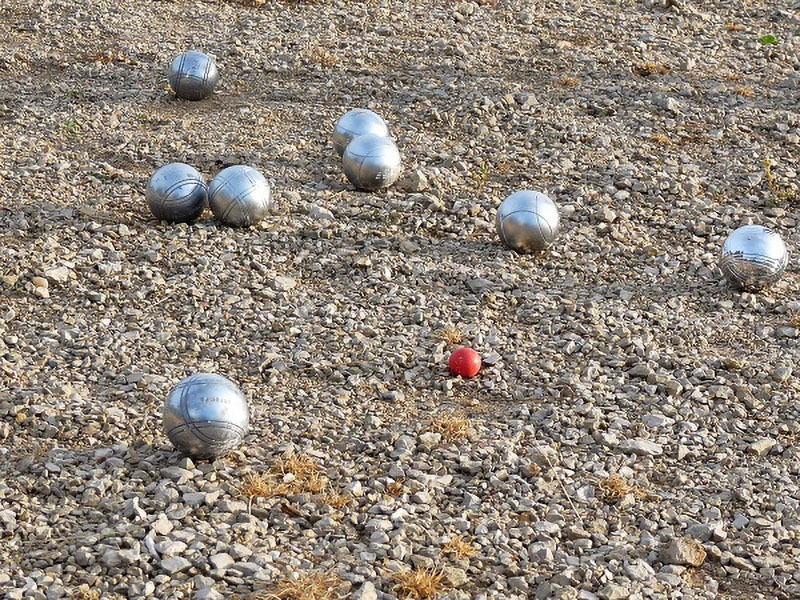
[719,225,789,290]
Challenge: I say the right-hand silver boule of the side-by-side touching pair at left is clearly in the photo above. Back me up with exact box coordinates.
[208,165,272,227]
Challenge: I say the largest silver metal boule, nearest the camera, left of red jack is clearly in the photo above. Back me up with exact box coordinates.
[163,373,250,458]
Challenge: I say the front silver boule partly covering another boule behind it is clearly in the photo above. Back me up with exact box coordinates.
[342,135,402,191]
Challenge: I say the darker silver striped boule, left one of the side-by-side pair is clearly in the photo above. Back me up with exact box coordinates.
[145,163,208,223]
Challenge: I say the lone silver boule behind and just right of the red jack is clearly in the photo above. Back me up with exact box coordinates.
[497,190,560,253]
